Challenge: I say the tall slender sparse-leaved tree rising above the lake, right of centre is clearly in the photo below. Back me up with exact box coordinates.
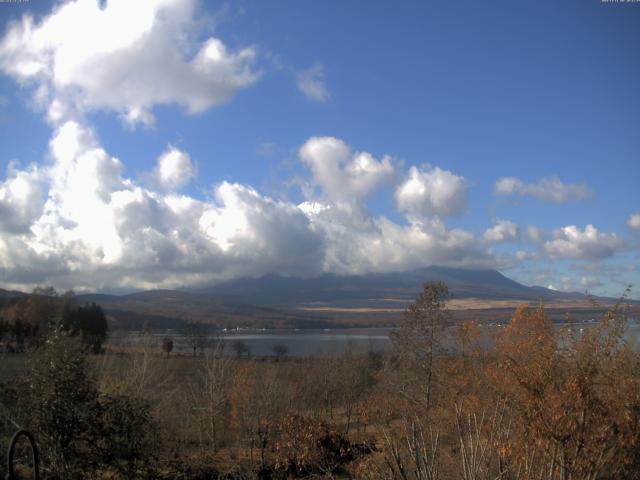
[390,282,451,412]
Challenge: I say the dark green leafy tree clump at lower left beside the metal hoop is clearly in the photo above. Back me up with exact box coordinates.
[26,327,154,479]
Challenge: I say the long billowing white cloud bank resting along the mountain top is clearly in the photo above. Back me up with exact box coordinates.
[0,121,510,290]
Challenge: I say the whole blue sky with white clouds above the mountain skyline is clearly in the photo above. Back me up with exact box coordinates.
[0,0,640,298]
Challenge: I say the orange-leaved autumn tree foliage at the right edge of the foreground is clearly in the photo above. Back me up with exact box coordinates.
[496,298,640,480]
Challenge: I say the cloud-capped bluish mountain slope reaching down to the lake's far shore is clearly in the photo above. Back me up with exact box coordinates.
[0,267,610,329]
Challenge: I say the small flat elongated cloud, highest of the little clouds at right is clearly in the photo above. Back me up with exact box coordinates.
[495,176,592,204]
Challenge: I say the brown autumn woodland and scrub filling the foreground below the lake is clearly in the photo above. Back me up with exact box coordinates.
[0,283,640,480]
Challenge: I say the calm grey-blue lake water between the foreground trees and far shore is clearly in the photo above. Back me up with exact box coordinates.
[107,321,640,357]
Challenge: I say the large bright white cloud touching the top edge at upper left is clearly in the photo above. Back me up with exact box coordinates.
[0,0,258,125]
